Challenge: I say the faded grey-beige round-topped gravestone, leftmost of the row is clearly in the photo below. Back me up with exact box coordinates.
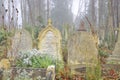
[9,29,32,56]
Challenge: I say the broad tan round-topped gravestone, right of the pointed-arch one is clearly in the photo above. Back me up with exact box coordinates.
[68,31,98,66]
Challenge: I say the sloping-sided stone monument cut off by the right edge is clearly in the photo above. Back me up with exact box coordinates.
[107,29,120,64]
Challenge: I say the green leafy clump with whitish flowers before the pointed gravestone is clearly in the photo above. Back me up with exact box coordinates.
[16,49,63,68]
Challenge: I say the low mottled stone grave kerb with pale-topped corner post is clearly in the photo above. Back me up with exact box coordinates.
[0,65,55,80]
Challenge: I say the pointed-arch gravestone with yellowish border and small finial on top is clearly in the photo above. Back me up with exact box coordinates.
[38,19,62,59]
